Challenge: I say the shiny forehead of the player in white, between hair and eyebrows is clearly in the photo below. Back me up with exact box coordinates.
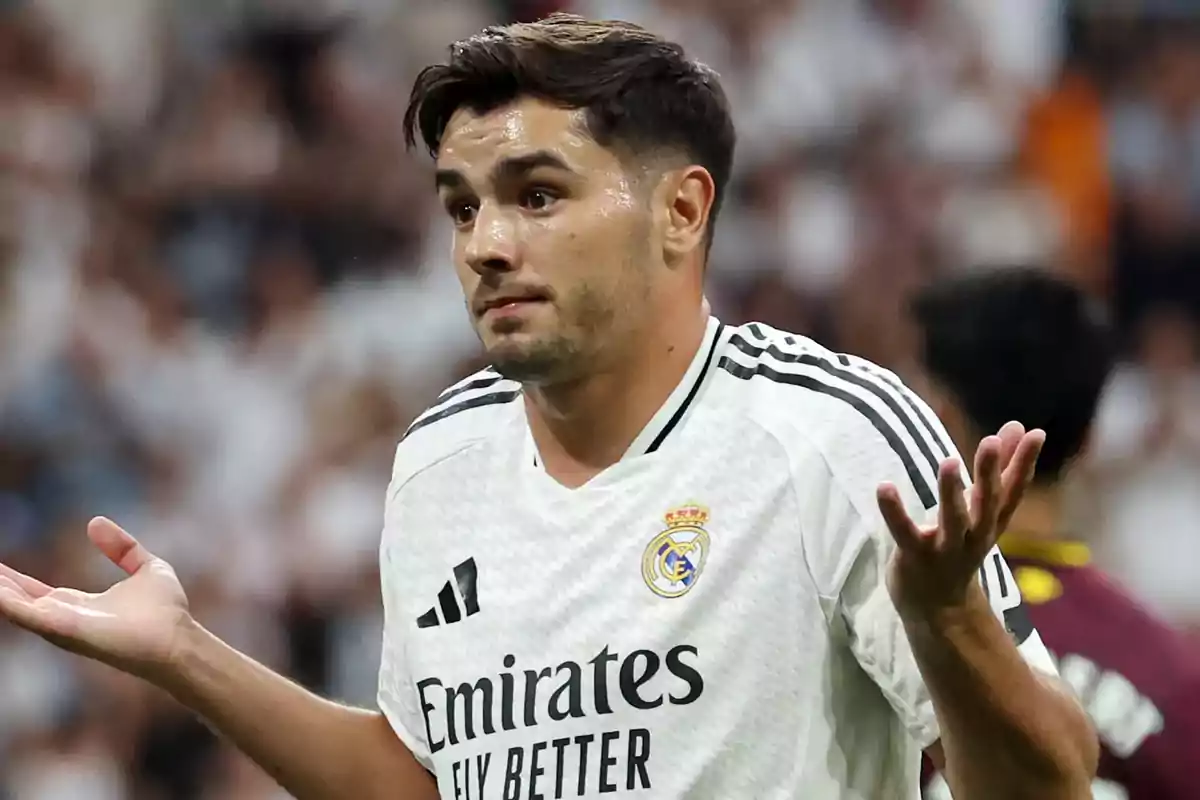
[437,97,623,182]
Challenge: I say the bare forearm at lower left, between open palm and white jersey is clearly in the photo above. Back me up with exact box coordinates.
[155,624,437,800]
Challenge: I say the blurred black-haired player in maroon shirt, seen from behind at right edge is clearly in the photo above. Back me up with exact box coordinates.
[913,269,1200,800]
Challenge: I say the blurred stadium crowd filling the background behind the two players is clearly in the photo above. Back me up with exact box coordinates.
[0,0,1200,800]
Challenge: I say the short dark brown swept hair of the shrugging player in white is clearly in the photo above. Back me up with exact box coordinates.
[404,13,736,241]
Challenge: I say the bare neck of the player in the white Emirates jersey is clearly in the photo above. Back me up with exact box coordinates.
[526,304,708,487]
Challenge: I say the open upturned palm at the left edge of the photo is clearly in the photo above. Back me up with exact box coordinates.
[0,517,191,678]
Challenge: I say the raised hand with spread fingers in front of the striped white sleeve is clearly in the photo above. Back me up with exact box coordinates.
[877,422,1045,618]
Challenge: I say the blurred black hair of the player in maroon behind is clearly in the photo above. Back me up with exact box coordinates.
[912,267,1114,485]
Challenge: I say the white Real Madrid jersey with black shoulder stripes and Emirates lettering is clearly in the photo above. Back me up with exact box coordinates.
[379,320,1054,800]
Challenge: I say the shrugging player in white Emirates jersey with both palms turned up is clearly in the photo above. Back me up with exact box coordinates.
[0,17,1096,800]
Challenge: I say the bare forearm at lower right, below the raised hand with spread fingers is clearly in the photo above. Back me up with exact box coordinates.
[905,587,1098,800]
